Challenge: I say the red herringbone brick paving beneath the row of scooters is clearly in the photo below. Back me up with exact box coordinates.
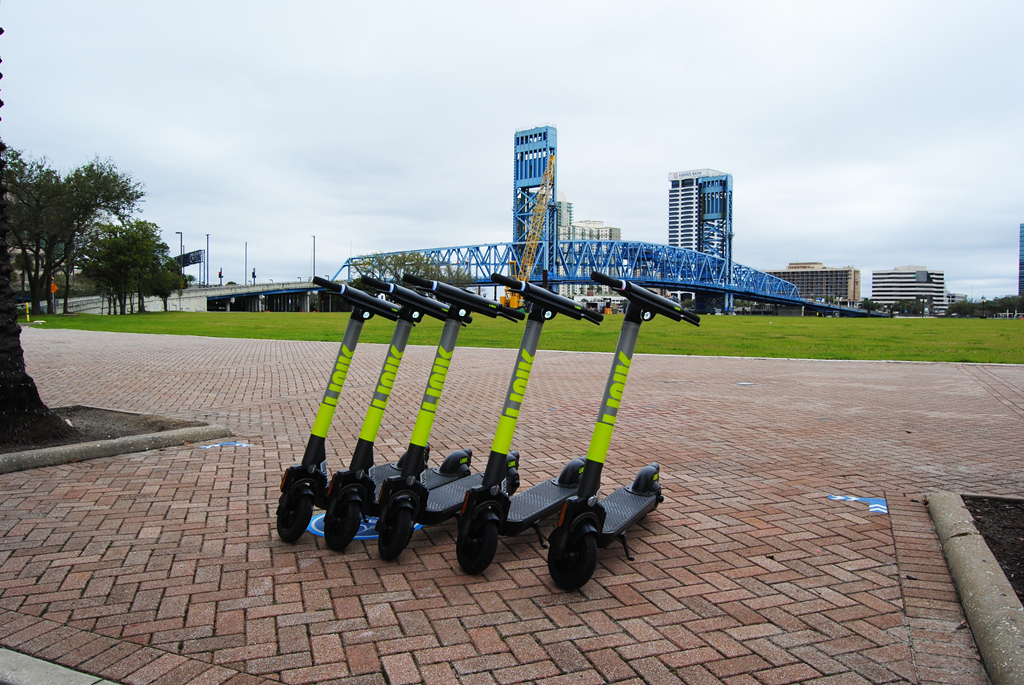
[0,330,1024,685]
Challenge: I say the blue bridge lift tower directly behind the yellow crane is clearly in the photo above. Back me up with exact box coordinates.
[512,126,558,284]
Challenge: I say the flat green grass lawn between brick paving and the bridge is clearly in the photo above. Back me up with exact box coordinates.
[22,312,1024,363]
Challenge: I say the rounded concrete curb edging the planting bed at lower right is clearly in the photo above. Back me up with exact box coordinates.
[928,493,1024,685]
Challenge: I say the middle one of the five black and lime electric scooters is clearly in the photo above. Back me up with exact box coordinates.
[376,273,526,560]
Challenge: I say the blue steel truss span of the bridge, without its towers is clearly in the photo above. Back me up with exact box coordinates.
[334,241,866,316]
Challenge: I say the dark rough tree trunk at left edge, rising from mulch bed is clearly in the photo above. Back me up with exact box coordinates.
[0,142,74,444]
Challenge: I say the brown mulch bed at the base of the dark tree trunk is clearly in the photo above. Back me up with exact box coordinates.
[0,404,206,454]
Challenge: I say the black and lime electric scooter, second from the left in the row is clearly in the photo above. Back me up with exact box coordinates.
[324,275,473,552]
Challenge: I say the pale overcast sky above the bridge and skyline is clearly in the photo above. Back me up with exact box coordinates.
[0,0,1024,298]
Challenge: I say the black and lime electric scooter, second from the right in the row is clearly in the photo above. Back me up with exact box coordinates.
[417,273,604,573]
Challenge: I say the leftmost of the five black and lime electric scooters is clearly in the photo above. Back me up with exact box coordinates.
[278,277,400,543]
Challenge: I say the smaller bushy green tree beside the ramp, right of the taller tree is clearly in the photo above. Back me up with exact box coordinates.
[82,219,167,314]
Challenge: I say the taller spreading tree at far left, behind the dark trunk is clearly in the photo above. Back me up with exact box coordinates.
[3,149,145,313]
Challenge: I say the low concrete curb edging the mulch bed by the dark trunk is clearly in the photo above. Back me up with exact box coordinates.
[0,426,232,473]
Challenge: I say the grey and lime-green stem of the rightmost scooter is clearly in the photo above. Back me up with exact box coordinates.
[578,301,641,500]
